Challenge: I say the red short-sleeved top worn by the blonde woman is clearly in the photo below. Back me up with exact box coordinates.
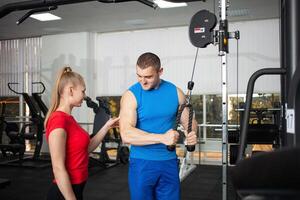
[46,111,90,184]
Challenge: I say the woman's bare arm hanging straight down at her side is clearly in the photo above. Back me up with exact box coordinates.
[49,128,76,200]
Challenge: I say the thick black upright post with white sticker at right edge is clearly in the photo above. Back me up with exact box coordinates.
[280,0,300,146]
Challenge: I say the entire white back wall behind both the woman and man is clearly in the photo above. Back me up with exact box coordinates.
[41,19,280,122]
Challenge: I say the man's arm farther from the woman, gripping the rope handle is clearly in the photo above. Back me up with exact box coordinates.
[177,88,198,145]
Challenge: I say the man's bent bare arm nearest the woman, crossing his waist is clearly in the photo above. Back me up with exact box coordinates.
[120,91,178,145]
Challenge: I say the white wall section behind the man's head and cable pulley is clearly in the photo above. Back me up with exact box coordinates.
[96,19,280,95]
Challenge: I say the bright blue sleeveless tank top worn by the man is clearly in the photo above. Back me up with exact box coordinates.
[129,80,179,160]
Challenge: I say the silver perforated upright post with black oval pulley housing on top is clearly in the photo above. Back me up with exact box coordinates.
[189,0,240,200]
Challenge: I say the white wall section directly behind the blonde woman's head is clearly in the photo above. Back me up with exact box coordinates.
[41,33,95,122]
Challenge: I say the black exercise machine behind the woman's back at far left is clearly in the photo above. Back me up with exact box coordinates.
[1,83,51,168]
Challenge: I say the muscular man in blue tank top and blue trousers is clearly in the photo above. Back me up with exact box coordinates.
[120,52,197,200]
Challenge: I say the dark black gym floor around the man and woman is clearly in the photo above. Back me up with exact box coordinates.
[0,164,236,200]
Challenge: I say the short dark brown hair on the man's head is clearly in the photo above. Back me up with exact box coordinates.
[136,52,161,71]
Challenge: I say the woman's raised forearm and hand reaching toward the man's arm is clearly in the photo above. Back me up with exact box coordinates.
[88,117,120,152]
